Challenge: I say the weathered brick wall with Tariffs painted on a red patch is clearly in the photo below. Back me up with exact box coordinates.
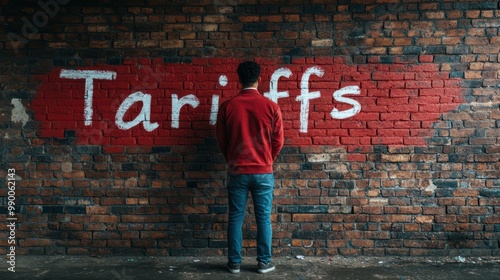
[0,0,500,256]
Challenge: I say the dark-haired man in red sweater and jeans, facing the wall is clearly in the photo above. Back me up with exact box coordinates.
[217,61,284,273]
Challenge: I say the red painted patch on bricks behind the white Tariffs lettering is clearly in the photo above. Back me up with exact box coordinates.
[31,57,463,149]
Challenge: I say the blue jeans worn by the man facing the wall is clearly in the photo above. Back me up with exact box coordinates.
[227,173,274,264]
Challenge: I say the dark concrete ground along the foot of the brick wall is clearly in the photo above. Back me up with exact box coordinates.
[0,256,500,280]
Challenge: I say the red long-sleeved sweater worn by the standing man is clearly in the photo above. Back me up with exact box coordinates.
[217,89,284,174]
